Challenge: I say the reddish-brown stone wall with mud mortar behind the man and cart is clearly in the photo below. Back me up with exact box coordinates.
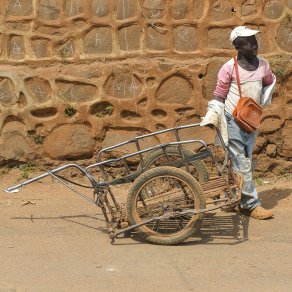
[0,0,292,170]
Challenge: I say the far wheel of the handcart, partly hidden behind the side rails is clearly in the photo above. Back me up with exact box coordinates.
[140,147,209,183]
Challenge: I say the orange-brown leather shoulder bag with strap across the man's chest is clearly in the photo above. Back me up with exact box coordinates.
[232,57,263,133]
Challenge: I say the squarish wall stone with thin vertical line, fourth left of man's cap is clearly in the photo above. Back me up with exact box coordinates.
[119,25,142,52]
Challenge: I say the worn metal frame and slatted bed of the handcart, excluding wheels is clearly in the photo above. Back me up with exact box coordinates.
[5,124,241,244]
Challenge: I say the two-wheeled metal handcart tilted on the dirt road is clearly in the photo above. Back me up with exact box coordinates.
[5,124,241,245]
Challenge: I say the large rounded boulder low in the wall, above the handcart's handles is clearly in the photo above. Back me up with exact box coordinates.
[43,125,95,159]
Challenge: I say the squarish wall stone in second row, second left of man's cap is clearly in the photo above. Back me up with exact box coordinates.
[173,26,198,52]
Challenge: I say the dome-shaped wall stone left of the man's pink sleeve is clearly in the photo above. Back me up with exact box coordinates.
[155,75,193,104]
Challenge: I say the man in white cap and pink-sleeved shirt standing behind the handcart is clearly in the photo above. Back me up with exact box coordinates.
[203,26,275,219]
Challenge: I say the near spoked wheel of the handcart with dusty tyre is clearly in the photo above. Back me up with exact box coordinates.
[127,166,206,245]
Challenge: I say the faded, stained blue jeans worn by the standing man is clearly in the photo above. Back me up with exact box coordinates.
[226,113,261,210]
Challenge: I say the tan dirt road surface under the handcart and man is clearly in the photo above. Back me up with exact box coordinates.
[0,170,292,292]
